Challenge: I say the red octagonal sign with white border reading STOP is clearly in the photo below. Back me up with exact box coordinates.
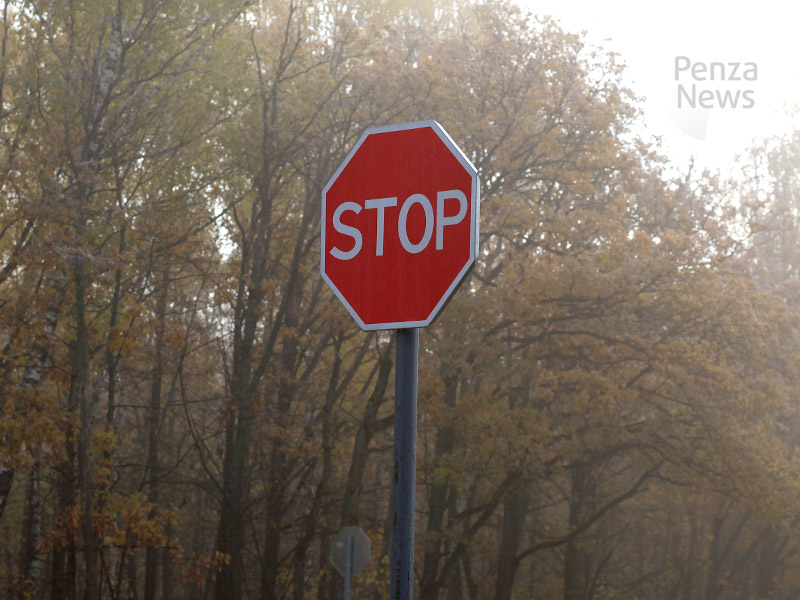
[320,121,480,330]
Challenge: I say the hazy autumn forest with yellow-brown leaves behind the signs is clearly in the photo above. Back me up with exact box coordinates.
[0,0,800,600]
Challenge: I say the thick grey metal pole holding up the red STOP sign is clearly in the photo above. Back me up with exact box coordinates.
[391,328,419,600]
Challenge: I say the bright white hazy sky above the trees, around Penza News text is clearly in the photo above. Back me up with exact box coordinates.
[523,0,800,171]
